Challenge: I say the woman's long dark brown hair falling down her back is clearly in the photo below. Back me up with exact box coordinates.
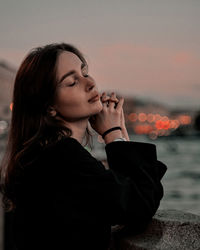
[0,43,92,210]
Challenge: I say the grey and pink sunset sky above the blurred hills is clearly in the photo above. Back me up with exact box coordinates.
[0,0,200,109]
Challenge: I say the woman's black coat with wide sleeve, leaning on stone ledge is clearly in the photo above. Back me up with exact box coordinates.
[6,138,166,250]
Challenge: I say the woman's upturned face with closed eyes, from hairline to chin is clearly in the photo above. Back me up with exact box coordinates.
[54,51,103,122]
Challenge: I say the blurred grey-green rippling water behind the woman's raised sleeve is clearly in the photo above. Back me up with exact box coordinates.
[91,135,200,215]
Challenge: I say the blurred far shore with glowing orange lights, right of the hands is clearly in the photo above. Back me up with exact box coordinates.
[124,97,195,139]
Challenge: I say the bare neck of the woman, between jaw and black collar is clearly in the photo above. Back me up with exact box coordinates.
[66,119,88,144]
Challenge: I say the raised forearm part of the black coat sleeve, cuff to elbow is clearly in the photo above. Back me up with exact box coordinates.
[105,141,167,230]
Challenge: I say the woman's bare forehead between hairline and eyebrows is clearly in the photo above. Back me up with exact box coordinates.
[57,51,82,77]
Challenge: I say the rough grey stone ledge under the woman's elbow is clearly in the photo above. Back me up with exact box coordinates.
[111,210,200,250]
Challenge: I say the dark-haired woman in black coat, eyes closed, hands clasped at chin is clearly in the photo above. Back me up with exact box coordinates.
[1,43,166,250]
